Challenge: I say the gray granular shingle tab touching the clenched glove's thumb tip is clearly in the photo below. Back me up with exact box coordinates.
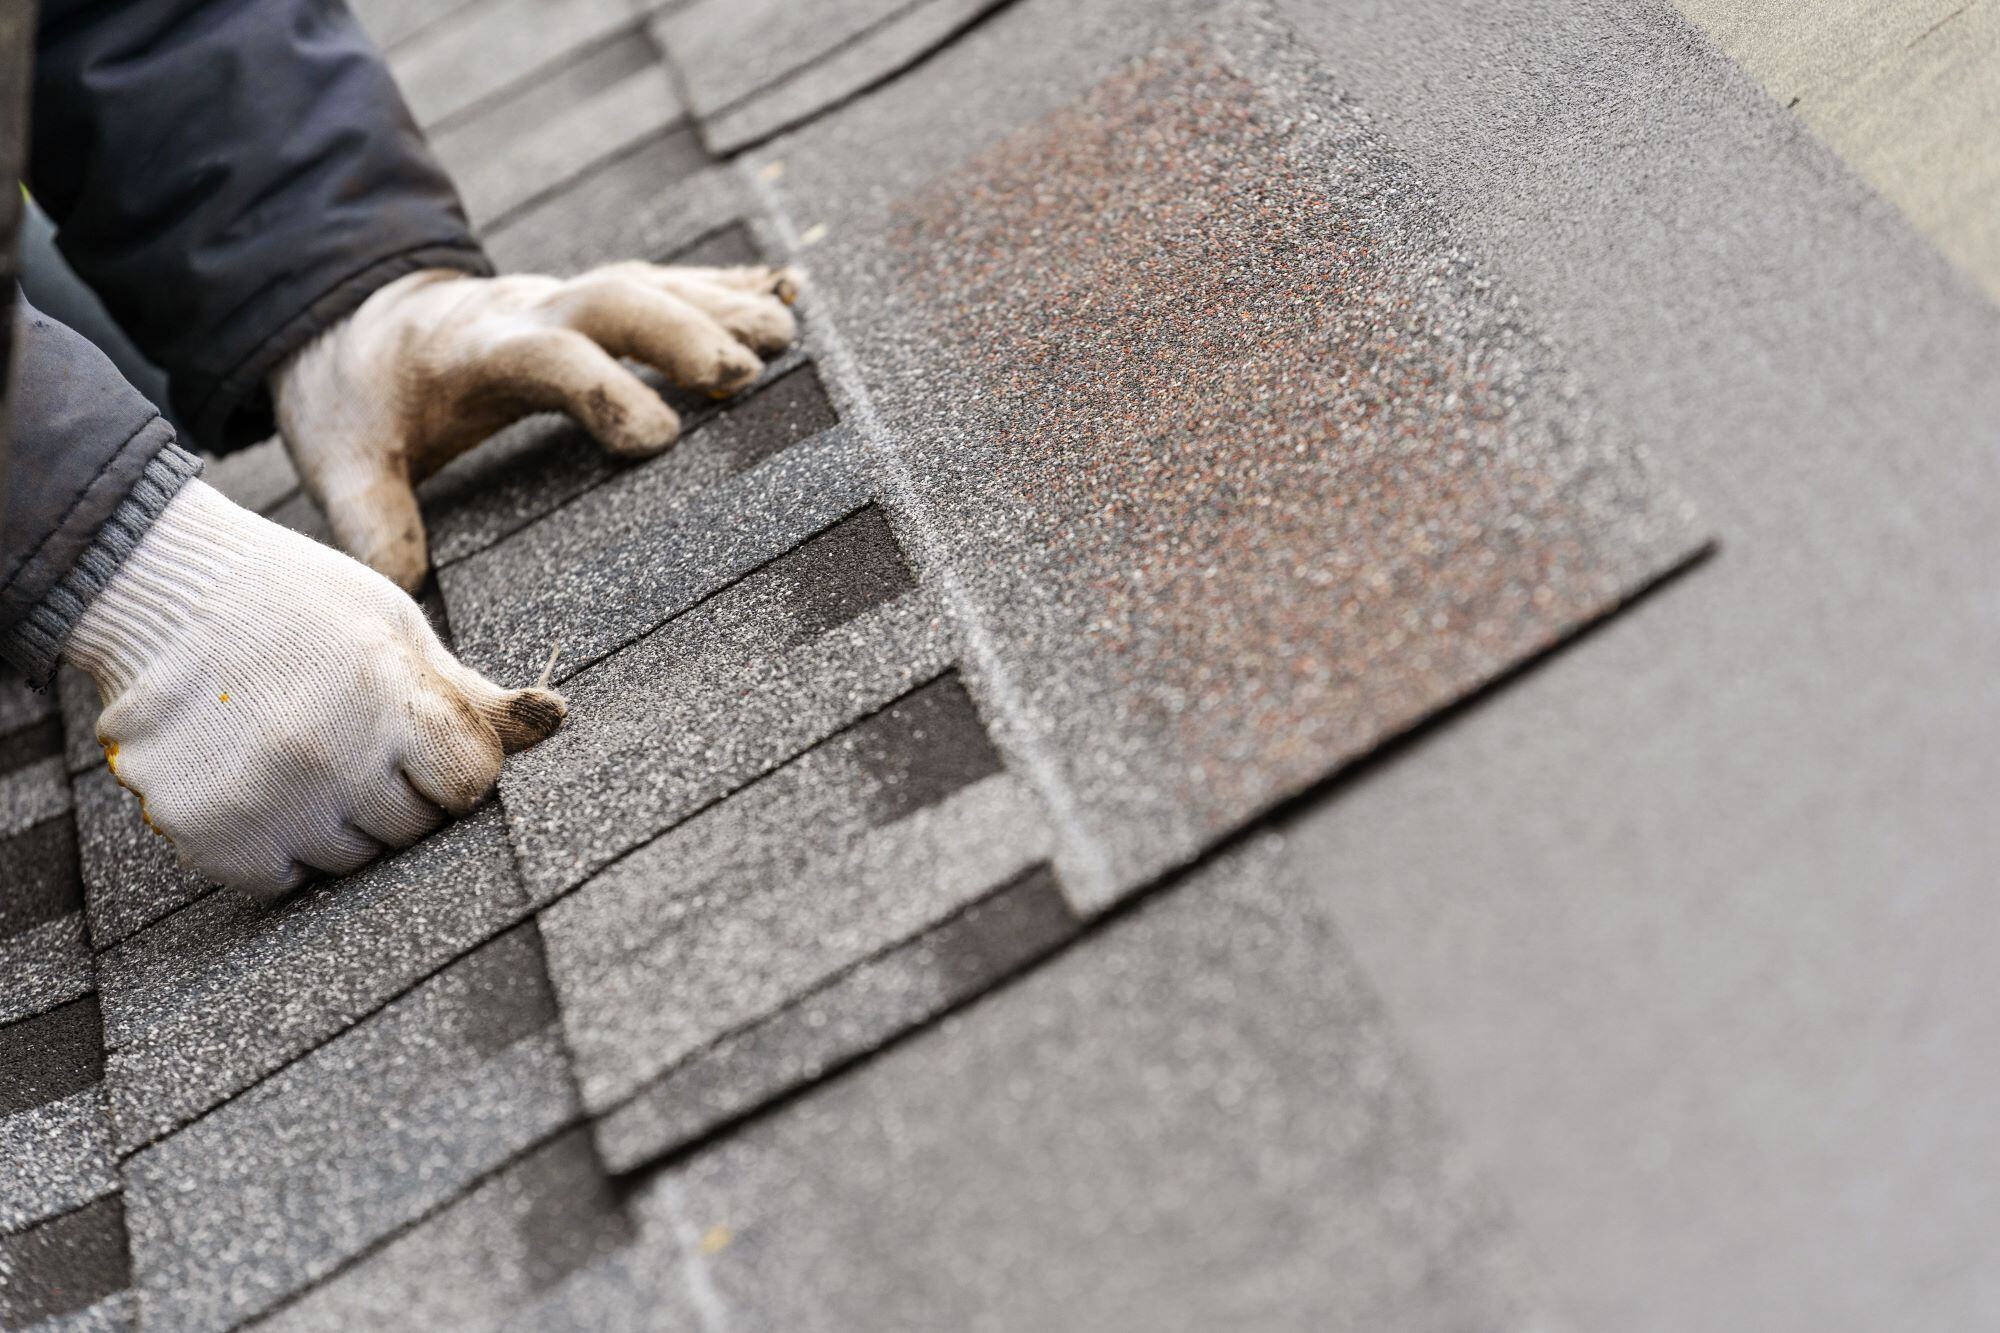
[500,506,954,901]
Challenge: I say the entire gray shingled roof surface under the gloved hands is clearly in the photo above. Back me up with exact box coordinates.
[0,0,2000,1333]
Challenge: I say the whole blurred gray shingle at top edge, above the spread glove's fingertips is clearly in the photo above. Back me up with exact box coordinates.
[652,0,1002,154]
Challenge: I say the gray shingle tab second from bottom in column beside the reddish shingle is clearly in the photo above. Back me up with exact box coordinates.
[542,677,1050,1111]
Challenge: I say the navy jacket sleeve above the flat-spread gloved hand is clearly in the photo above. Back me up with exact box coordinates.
[28,0,492,448]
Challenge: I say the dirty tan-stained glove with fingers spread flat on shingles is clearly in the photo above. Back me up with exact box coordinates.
[270,262,796,588]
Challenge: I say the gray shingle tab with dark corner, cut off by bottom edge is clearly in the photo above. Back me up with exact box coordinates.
[260,1129,700,1333]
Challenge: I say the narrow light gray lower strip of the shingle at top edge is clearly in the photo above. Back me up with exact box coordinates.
[702,0,1004,154]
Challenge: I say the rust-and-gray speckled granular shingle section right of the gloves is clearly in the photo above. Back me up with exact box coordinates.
[844,20,1700,905]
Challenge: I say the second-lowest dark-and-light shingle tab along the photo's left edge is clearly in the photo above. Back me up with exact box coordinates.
[0,993,116,1231]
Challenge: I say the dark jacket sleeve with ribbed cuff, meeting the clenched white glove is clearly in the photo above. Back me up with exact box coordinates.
[0,298,202,685]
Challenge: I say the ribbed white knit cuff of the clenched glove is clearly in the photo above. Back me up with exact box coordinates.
[62,480,264,703]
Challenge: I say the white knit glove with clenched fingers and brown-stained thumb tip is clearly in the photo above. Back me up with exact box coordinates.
[62,480,564,899]
